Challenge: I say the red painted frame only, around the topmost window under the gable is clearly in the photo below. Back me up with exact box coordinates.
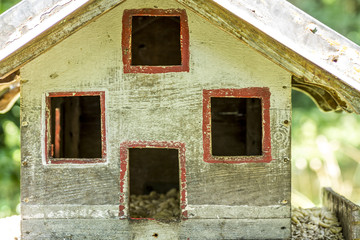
[122,8,189,73]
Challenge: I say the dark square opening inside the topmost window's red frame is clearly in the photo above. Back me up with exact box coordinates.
[131,16,181,66]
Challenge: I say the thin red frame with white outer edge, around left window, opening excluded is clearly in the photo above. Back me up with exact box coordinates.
[45,91,106,164]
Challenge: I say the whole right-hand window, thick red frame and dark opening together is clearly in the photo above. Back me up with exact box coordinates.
[203,87,271,163]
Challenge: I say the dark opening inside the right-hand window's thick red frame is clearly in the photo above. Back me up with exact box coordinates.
[211,97,262,156]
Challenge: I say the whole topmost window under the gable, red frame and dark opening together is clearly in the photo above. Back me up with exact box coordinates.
[122,9,189,73]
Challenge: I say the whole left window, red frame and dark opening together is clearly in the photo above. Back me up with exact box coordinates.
[47,92,105,163]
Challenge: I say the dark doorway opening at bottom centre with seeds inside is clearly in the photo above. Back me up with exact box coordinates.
[129,148,180,219]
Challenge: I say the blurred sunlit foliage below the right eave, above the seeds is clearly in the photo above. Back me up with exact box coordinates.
[292,91,360,207]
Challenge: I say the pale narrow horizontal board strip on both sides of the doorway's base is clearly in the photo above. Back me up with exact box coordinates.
[21,203,290,219]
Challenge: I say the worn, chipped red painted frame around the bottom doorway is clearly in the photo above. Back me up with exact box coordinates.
[119,141,188,220]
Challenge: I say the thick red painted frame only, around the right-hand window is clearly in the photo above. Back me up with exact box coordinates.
[203,87,272,163]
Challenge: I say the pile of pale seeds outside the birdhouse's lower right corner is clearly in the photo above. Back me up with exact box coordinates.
[291,208,344,240]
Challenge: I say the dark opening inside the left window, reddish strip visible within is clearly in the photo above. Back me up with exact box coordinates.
[50,96,102,158]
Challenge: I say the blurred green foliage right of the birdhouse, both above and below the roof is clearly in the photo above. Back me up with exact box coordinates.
[289,0,360,205]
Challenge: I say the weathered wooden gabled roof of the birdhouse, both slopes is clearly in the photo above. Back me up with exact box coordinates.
[0,0,360,114]
